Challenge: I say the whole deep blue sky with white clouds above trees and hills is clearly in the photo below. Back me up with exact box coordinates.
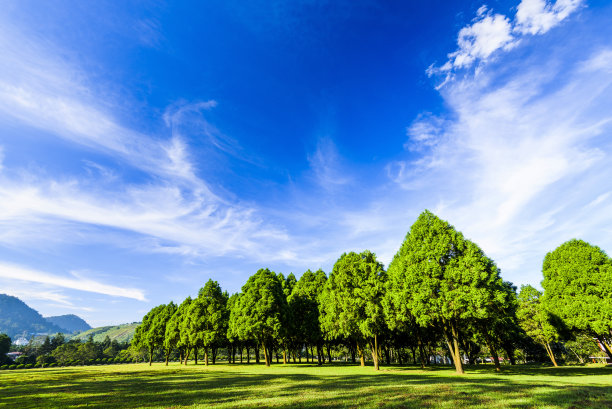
[0,0,612,325]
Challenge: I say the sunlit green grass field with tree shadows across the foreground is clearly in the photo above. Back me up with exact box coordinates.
[0,363,612,409]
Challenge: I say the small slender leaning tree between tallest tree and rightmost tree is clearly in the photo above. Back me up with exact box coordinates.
[516,285,559,366]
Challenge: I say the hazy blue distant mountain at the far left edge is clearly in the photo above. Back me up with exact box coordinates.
[0,294,66,339]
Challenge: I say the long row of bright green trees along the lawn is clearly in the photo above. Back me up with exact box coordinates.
[132,211,612,373]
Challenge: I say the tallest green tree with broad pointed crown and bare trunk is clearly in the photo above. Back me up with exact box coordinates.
[389,210,506,374]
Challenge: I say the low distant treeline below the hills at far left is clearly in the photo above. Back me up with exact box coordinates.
[0,333,139,369]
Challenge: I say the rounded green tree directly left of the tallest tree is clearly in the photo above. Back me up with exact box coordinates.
[320,250,386,370]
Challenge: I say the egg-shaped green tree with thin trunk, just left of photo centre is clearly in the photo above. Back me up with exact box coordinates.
[230,268,287,366]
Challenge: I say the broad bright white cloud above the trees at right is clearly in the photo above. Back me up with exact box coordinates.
[390,49,612,283]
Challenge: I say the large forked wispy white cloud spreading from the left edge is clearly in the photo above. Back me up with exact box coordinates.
[0,15,287,264]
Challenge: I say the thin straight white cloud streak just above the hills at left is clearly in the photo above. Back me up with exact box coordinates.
[0,263,145,302]
